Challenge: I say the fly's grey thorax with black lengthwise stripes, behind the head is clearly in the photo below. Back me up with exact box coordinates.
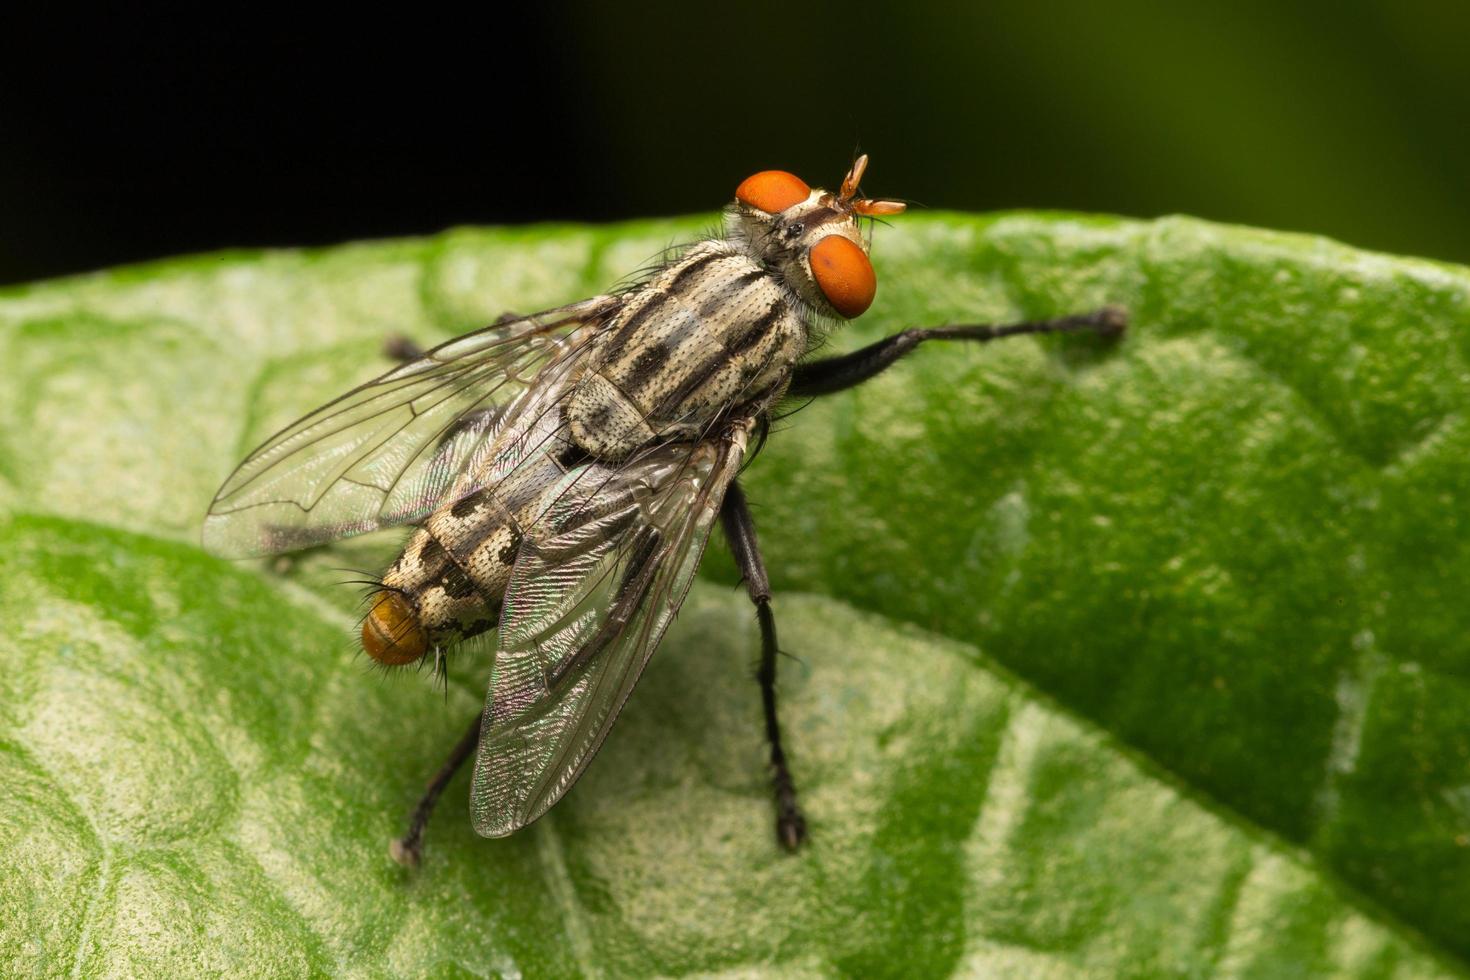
[567,244,806,460]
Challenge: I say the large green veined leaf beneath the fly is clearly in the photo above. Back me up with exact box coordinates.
[0,215,1470,977]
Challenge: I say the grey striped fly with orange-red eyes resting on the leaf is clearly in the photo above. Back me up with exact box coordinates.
[203,156,1125,864]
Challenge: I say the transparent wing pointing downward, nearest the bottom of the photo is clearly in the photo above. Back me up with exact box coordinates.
[470,425,748,837]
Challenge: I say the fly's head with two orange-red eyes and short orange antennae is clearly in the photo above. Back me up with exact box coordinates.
[731,154,904,320]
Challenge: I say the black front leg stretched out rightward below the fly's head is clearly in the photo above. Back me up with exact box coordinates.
[788,306,1127,398]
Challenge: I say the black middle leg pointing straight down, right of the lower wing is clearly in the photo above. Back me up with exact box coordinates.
[720,483,807,851]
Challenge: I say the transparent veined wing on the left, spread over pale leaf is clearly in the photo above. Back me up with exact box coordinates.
[204,297,620,558]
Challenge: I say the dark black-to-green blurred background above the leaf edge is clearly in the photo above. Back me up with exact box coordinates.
[0,0,1470,282]
